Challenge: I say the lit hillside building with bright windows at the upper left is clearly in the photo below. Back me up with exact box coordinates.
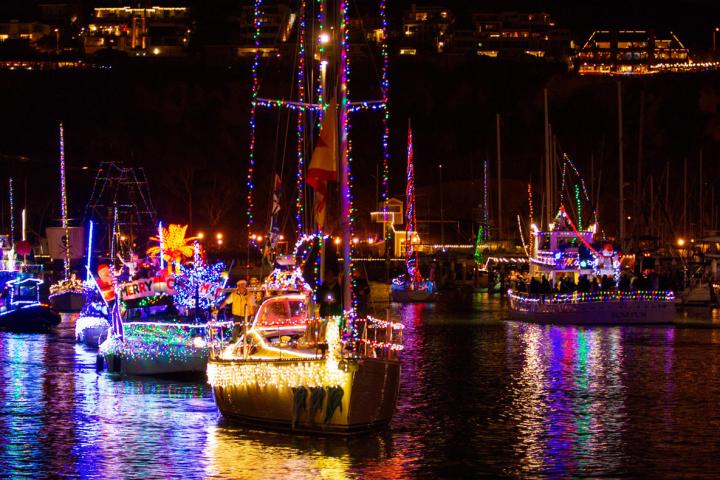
[84,1,192,56]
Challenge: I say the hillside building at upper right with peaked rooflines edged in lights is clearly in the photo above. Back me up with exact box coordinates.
[577,30,689,75]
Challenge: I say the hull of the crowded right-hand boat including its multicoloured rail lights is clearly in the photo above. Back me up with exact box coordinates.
[508,290,675,325]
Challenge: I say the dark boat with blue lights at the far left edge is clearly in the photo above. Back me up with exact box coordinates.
[0,270,60,332]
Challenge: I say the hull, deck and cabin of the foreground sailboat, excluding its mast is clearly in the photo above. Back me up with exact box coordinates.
[207,262,402,434]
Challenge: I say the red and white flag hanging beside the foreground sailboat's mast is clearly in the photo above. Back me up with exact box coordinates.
[307,99,338,231]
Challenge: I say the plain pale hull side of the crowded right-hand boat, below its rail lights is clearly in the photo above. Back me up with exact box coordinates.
[510,293,675,325]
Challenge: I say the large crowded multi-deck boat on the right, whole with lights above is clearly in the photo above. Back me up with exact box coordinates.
[508,155,675,325]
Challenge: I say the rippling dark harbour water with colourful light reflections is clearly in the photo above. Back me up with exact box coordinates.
[0,295,720,479]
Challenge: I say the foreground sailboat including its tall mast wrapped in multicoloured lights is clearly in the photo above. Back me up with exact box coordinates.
[207,0,402,434]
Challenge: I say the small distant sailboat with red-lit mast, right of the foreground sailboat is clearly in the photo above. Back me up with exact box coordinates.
[390,125,438,303]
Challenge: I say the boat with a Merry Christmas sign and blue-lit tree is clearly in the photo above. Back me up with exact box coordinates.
[99,236,231,375]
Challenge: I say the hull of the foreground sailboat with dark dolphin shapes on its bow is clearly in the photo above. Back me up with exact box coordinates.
[210,358,400,435]
